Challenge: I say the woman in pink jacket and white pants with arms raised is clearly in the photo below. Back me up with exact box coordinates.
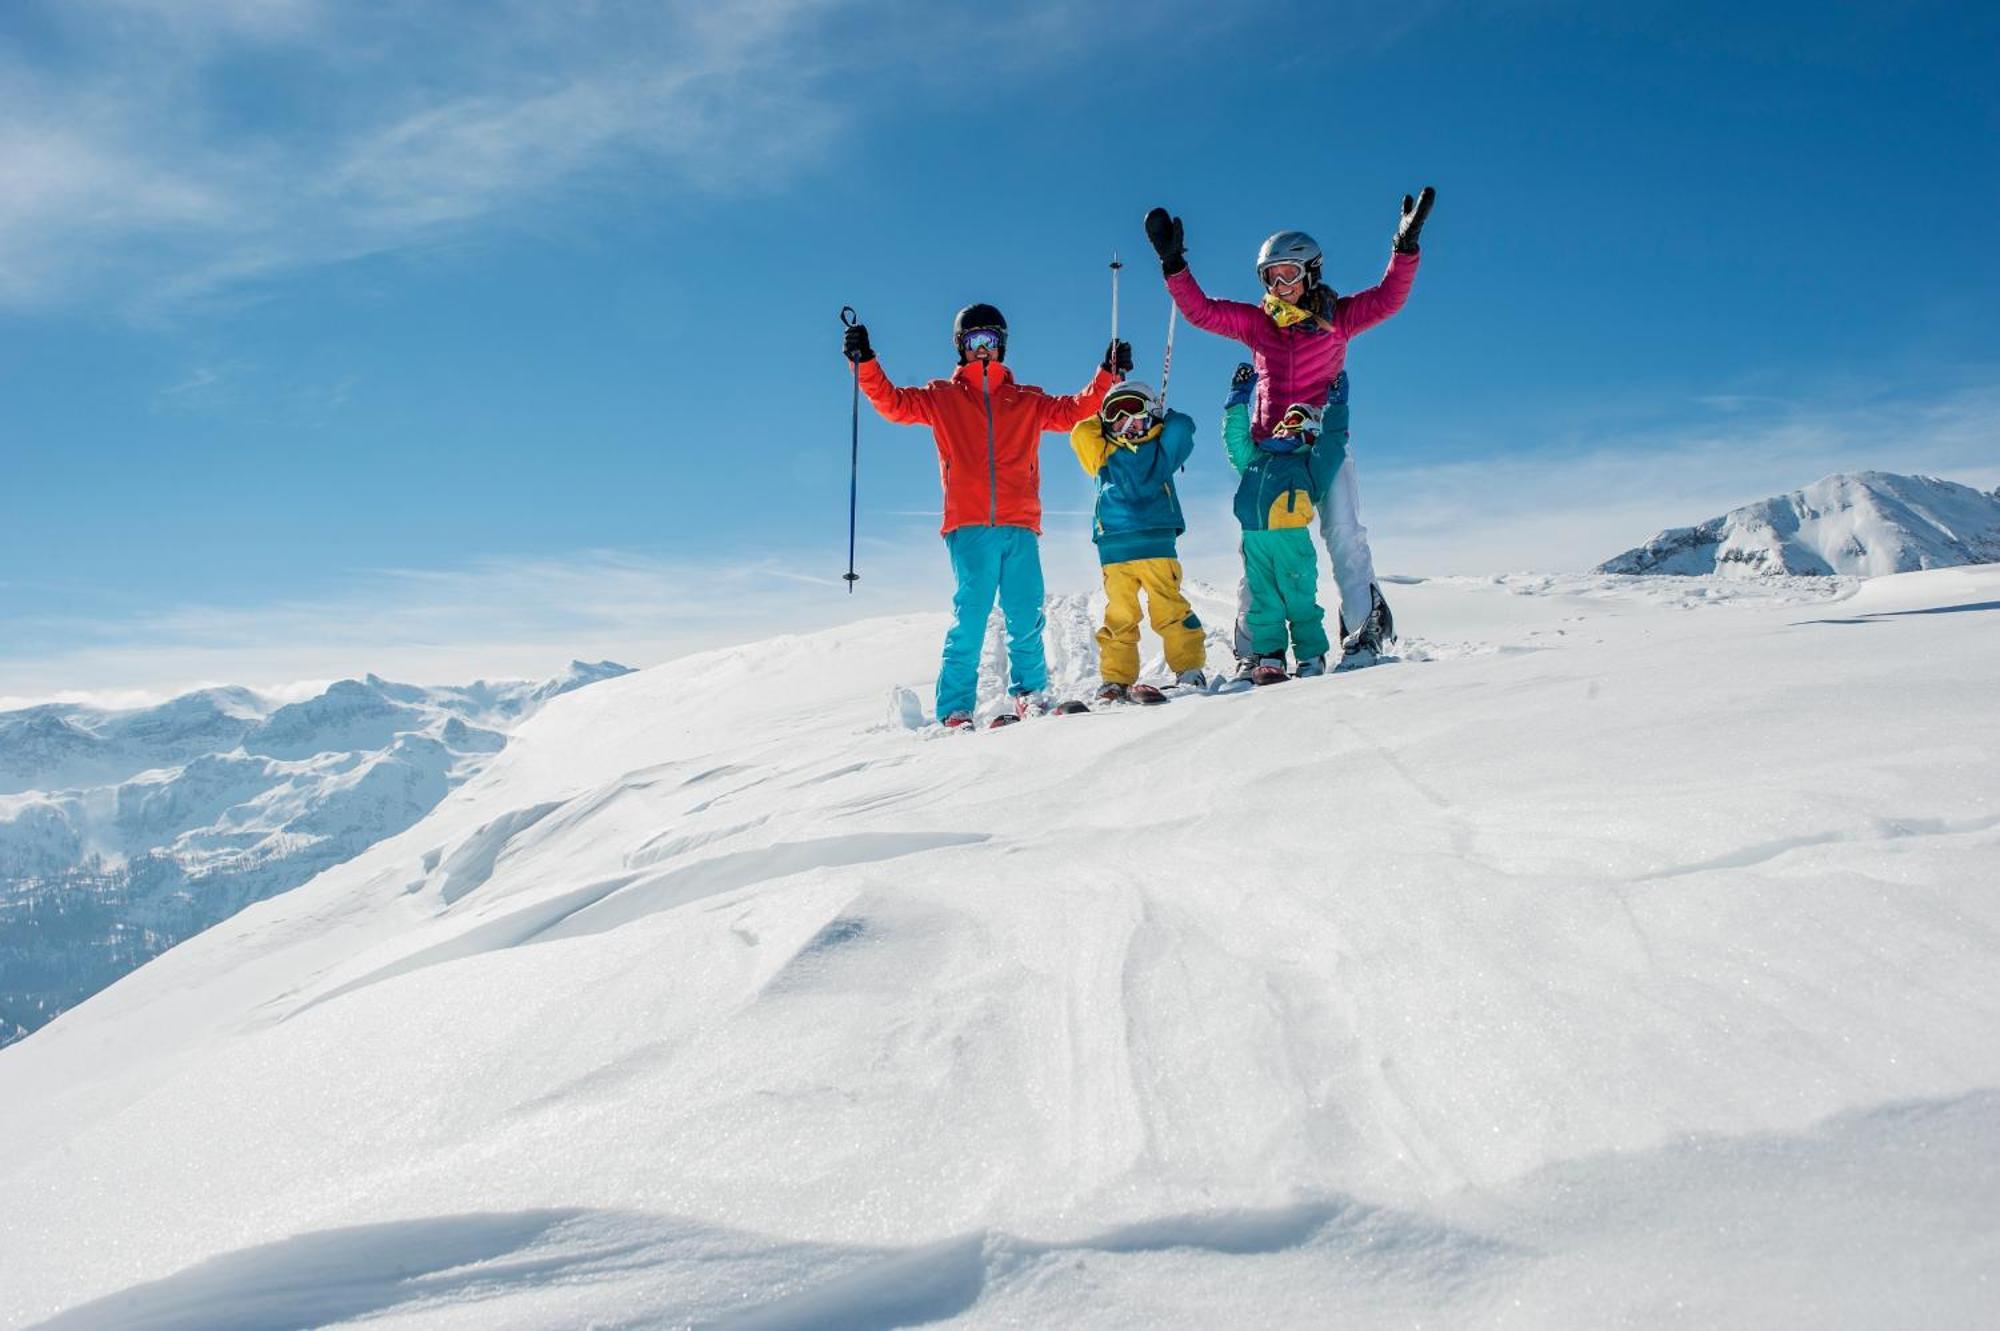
[1146,186,1436,675]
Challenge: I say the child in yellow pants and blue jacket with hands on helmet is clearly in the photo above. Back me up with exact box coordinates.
[1070,380,1208,701]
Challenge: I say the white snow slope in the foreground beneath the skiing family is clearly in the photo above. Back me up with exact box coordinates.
[0,568,2000,1327]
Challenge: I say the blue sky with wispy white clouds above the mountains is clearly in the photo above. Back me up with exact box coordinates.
[0,0,2000,699]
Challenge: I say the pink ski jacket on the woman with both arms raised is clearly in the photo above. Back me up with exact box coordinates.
[1166,254,1418,440]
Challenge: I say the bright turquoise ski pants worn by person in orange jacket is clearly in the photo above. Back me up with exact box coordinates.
[938,528,1048,721]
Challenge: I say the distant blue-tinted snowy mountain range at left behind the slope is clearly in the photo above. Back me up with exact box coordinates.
[0,662,628,1045]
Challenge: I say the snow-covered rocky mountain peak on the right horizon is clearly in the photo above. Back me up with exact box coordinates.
[1596,472,2000,578]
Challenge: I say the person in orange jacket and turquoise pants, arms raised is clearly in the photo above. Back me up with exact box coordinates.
[844,304,1132,727]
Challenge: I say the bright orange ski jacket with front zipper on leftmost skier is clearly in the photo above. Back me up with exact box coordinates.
[860,360,1118,536]
